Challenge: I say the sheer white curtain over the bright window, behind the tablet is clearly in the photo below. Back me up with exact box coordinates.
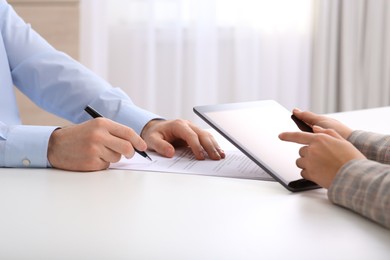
[81,0,312,121]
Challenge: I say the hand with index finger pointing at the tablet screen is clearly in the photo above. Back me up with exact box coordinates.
[279,126,366,188]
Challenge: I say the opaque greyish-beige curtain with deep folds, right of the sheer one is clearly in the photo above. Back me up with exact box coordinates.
[311,0,390,113]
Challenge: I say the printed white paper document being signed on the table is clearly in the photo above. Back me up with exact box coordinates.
[110,130,274,181]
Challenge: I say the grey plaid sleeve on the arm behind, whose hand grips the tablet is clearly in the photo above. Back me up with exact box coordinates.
[348,130,390,164]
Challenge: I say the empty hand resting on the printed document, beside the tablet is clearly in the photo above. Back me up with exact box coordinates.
[141,119,225,160]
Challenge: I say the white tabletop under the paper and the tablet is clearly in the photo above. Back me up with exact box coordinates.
[0,108,390,260]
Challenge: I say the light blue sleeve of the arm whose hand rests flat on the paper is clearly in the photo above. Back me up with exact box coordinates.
[0,0,161,134]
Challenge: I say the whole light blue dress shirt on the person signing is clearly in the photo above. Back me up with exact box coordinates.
[0,0,159,167]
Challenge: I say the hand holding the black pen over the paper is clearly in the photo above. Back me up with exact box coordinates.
[48,118,147,171]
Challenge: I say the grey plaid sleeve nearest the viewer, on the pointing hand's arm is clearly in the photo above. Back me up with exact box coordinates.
[328,159,390,228]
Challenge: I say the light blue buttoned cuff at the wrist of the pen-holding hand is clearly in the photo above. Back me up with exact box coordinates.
[4,125,57,168]
